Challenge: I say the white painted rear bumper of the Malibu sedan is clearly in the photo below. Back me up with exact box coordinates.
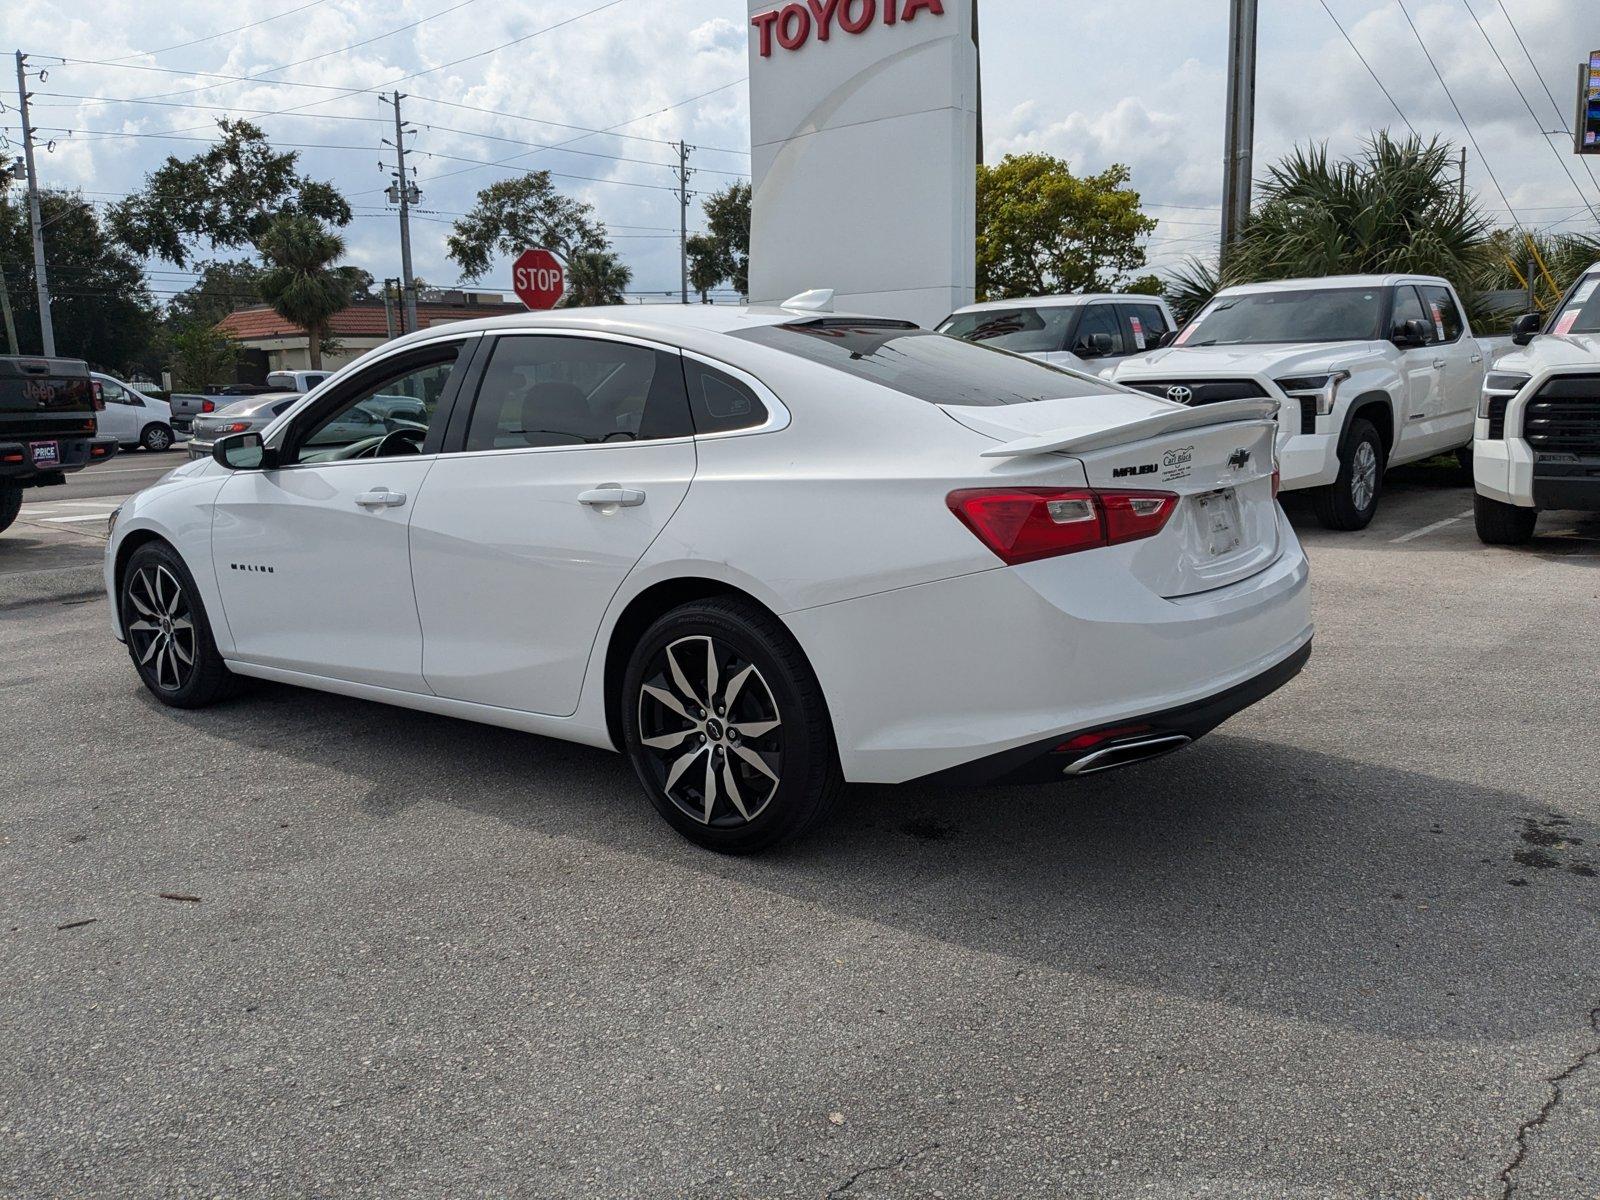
[784,512,1312,782]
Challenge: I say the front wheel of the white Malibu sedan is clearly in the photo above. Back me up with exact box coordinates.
[118,542,237,709]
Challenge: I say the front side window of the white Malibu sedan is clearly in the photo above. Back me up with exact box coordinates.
[290,342,461,462]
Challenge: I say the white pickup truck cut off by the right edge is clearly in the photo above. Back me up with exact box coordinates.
[1472,262,1600,546]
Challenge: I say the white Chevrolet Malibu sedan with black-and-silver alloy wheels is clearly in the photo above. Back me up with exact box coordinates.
[106,306,1312,851]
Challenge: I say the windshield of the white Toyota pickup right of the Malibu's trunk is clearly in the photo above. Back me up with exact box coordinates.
[1178,288,1389,346]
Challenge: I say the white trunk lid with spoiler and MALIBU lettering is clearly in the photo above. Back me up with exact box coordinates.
[944,392,1282,598]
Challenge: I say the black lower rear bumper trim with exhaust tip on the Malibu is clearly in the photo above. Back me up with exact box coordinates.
[920,642,1310,787]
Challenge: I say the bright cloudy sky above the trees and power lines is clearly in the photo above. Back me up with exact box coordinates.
[0,0,1600,302]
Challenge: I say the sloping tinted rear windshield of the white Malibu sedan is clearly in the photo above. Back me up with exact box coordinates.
[731,322,1112,408]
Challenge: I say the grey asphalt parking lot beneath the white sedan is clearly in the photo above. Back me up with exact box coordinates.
[0,464,1600,1200]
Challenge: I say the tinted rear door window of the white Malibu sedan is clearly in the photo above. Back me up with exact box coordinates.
[466,334,693,451]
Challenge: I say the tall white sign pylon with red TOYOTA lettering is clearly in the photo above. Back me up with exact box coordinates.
[749,0,982,325]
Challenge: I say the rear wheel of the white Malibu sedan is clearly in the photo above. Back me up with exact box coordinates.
[621,598,843,854]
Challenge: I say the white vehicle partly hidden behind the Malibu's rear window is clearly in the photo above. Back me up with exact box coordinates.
[939,293,1178,376]
